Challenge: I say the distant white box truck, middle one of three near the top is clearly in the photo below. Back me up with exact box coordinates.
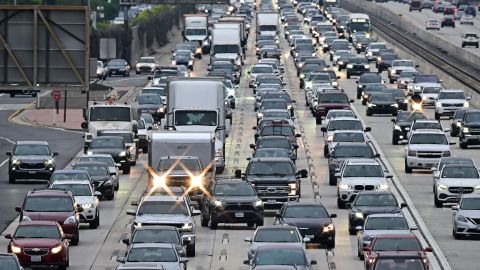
[210,26,243,67]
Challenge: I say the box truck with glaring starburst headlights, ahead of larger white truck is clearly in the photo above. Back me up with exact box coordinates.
[148,131,215,201]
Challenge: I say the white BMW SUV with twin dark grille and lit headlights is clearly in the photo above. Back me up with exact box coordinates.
[335,159,393,209]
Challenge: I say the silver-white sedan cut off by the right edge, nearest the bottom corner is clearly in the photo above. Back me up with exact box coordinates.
[452,194,480,239]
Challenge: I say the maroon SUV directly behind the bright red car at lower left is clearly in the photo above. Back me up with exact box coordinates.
[15,189,83,245]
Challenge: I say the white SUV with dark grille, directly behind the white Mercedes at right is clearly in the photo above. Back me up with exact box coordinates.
[405,129,454,173]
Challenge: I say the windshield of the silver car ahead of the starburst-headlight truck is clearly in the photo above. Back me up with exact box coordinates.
[137,201,189,216]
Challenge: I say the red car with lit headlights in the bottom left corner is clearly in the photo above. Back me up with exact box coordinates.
[5,221,70,270]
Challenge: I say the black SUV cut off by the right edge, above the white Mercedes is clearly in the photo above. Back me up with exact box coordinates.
[458,110,480,149]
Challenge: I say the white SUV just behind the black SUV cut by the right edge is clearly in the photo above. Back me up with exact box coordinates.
[435,89,470,120]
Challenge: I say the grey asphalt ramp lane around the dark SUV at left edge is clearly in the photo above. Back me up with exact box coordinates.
[0,111,83,231]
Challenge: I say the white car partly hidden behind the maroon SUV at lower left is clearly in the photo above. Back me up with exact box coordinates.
[49,180,102,229]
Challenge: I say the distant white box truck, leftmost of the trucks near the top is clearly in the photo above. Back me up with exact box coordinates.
[182,14,210,54]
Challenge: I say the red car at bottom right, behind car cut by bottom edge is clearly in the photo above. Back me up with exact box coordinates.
[363,234,432,270]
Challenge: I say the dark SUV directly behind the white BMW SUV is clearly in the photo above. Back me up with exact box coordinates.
[327,142,380,186]
